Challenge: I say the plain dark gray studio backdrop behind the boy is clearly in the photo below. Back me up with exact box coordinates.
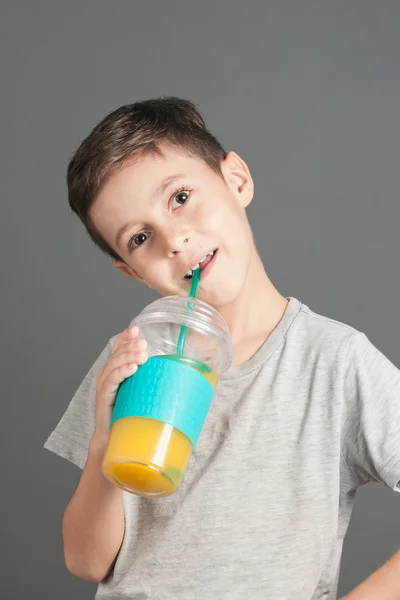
[0,0,400,600]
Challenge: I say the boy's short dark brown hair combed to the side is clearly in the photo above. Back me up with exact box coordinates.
[67,97,226,260]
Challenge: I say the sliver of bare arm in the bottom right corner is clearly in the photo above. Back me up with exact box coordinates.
[341,550,400,600]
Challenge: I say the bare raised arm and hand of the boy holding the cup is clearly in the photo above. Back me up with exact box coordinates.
[63,328,147,583]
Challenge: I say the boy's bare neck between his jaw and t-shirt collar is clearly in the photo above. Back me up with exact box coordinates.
[219,249,288,366]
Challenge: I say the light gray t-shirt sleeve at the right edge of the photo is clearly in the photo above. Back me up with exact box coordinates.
[343,332,400,492]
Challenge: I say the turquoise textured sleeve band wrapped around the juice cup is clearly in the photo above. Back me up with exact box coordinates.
[111,356,214,447]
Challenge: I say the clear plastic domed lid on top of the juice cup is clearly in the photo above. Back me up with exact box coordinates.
[132,296,233,374]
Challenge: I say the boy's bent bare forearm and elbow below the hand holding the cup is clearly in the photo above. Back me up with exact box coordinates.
[62,436,125,583]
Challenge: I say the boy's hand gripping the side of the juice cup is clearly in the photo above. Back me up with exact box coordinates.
[93,327,148,445]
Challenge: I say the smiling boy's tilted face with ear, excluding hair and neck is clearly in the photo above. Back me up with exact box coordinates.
[91,146,254,309]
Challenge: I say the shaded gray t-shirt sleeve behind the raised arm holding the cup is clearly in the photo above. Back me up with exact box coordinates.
[44,338,115,469]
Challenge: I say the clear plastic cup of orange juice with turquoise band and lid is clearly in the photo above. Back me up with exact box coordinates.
[102,296,232,498]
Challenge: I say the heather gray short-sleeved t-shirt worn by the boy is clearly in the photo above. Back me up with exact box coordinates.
[45,298,400,600]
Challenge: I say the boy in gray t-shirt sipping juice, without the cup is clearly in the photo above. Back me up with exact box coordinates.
[46,98,400,600]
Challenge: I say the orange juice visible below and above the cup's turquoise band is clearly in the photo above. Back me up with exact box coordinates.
[103,355,218,497]
